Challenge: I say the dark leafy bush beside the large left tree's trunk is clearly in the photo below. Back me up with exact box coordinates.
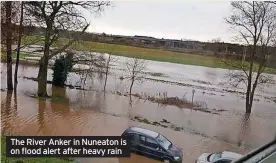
[52,55,73,87]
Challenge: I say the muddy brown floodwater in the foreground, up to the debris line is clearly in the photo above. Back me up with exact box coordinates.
[1,61,276,163]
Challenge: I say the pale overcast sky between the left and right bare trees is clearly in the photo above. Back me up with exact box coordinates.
[85,0,236,42]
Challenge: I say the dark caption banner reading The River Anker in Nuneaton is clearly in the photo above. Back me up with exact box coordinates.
[6,136,130,157]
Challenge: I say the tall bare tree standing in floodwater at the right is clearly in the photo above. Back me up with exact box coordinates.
[226,1,276,113]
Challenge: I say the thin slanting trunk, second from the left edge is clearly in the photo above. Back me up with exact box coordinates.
[14,1,23,91]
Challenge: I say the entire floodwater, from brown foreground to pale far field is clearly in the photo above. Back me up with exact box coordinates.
[1,51,276,163]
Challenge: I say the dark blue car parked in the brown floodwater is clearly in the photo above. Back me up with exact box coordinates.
[122,127,183,163]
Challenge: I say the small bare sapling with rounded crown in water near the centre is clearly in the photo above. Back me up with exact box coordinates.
[126,58,146,97]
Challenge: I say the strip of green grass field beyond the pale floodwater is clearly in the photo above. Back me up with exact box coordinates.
[19,36,276,73]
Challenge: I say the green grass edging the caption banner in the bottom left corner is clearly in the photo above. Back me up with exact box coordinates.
[1,136,73,163]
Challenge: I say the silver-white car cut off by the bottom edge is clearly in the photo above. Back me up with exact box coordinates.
[196,151,243,163]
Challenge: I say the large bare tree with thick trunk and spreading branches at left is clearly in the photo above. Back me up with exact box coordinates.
[23,1,110,96]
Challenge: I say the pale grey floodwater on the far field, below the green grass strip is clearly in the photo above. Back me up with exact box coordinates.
[18,46,276,112]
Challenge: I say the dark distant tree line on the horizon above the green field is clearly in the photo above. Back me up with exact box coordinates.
[1,22,276,63]
